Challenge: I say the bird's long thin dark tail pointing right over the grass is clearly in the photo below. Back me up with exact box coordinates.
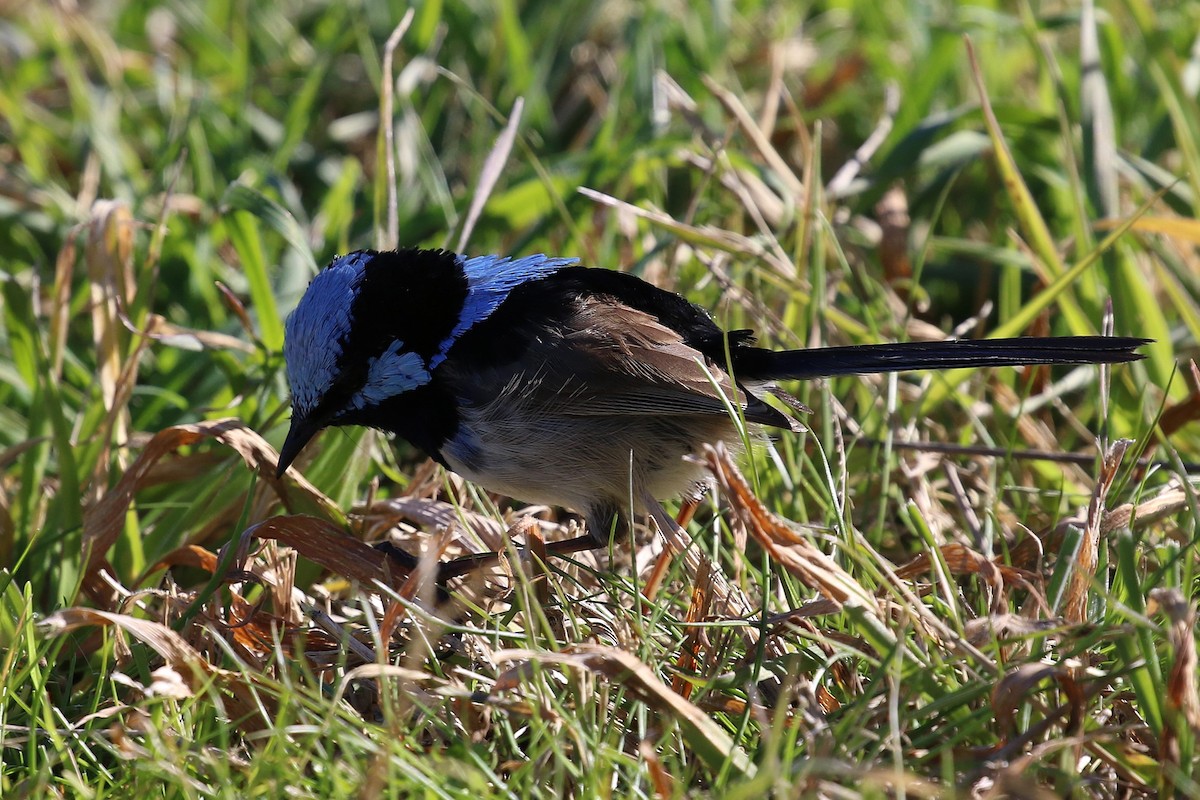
[734,336,1151,380]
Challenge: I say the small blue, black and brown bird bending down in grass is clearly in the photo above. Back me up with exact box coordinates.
[277,248,1150,547]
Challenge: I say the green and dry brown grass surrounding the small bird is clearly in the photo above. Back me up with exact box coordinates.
[0,0,1200,798]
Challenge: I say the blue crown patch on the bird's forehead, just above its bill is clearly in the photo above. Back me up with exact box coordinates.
[283,252,371,416]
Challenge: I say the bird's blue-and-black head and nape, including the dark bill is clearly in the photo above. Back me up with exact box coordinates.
[277,249,572,475]
